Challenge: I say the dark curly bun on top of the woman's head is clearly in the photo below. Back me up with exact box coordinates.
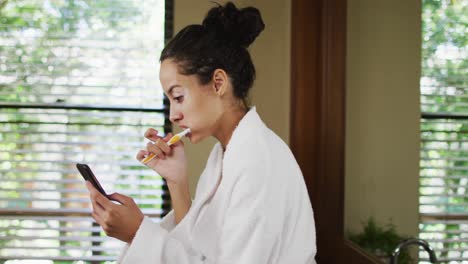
[202,2,265,48]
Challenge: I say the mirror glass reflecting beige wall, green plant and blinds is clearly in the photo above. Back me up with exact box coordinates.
[345,0,468,263]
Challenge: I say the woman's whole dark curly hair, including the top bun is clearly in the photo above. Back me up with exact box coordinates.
[160,2,265,99]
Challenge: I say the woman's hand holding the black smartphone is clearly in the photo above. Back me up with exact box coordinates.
[86,182,144,243]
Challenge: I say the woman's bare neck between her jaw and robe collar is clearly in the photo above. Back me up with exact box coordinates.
[214,105,247,151]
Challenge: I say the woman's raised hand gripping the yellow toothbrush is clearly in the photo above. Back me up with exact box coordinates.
[136,128,188,185]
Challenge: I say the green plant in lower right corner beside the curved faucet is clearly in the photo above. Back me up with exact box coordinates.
[348,217,413,264]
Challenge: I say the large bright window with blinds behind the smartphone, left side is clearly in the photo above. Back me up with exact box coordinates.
[0,0,172,263]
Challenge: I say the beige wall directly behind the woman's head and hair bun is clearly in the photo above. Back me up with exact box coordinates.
[174,0,290,195]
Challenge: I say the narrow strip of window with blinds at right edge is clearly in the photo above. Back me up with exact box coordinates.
[419,0,468,263]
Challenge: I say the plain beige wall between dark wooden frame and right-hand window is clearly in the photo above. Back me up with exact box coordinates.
[345,0,421,235]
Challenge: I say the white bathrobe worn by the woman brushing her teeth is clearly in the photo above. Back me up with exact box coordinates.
[119,108,316,264]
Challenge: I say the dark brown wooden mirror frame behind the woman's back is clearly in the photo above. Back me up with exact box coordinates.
[290,0,382,264]
